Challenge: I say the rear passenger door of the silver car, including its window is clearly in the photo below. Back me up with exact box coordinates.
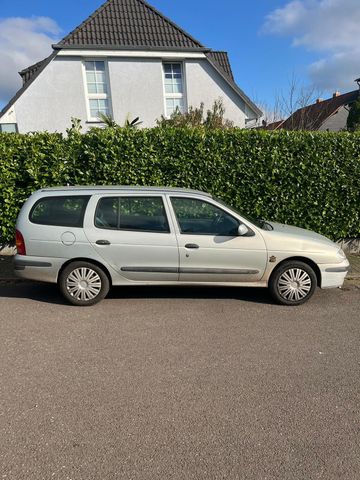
[84,194,179,282]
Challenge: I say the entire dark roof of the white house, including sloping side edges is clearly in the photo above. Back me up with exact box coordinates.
[0,0,262,117]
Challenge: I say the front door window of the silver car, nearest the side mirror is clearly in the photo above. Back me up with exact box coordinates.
[171,197,239,236]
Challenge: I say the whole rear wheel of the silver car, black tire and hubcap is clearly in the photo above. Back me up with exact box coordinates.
[59,261,110,307]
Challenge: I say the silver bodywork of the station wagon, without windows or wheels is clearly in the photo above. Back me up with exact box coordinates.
[15,187,349,294]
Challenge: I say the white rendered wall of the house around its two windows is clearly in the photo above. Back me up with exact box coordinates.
[0,56,252,133]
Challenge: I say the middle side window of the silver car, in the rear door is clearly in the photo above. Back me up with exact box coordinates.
[95,196,170,233]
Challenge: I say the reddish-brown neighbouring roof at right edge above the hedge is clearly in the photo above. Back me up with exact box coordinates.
[281,90,359,130]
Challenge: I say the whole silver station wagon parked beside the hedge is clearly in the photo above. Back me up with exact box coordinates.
[15,186,349,305]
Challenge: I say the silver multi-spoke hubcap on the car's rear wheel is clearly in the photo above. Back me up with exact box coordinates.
[66,267,101,301]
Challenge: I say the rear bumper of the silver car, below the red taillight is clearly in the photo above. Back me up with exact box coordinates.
[14,255,67,283]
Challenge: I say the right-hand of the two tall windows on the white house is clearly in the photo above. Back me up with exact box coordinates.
[163,63,185,117]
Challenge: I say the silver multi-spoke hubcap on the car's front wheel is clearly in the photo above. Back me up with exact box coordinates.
[278,268,311,301]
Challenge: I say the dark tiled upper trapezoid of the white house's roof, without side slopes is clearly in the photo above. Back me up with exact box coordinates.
[55,0,204,49]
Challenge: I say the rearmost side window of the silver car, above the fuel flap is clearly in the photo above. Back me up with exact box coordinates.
[29,195,90,227]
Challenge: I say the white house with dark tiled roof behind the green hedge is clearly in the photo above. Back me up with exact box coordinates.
[0,0,261,133]
